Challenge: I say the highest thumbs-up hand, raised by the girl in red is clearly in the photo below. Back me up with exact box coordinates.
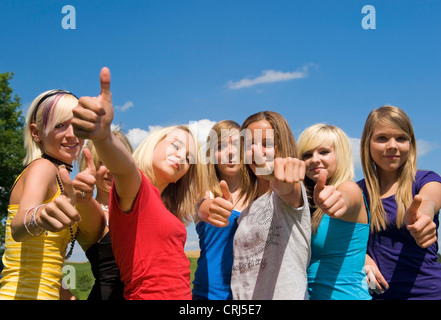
[72,67,113,140]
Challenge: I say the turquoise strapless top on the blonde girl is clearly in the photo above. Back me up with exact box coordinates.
[308,200,371,300]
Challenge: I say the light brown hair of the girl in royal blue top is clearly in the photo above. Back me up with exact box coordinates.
[207,120,240,197]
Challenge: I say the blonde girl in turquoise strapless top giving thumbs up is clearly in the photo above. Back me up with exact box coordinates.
[298,124,371,300]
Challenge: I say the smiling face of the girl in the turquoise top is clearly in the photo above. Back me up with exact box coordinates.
[302,143,337,182]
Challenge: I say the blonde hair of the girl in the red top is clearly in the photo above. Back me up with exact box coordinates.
[133,125,207,225]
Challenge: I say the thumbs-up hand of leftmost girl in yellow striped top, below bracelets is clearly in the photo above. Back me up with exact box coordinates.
[35,167,81,232]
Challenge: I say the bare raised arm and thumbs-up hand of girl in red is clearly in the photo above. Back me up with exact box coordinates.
[72,67,141,211]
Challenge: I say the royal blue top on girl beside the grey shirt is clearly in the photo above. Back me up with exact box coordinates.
[192,210,240,300]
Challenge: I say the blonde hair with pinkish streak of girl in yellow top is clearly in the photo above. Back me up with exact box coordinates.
[23,90,78,165]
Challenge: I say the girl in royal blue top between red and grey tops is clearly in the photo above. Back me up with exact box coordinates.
[192,120,246,300]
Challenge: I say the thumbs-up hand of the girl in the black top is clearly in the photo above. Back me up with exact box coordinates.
[72,147,96,202]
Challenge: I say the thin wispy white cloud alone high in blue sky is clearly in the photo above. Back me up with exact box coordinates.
[228,66,308,90]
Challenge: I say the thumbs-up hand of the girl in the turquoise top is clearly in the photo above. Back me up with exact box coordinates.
[313,170,348,218]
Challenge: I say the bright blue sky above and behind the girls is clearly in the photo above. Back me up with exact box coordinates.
[0,0,441,262]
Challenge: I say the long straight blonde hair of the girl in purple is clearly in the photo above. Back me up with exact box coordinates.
[360,106,417,232]
